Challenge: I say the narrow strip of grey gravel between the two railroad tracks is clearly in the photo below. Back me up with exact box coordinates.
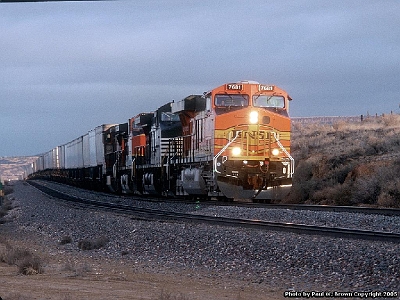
[36,181,400,233]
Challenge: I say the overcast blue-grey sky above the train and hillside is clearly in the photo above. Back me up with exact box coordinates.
[0,0,400,156]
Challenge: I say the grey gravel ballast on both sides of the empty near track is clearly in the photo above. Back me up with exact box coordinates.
[0,182,400,291]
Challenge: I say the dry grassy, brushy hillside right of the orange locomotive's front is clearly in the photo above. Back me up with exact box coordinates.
[284,115,400,207]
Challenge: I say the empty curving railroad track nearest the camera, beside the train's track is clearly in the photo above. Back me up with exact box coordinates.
[29,181,400,243]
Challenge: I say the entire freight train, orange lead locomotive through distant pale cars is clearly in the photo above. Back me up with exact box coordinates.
[29,81,294,201]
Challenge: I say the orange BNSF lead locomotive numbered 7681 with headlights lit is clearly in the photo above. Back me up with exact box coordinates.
[168,81,294,199]
